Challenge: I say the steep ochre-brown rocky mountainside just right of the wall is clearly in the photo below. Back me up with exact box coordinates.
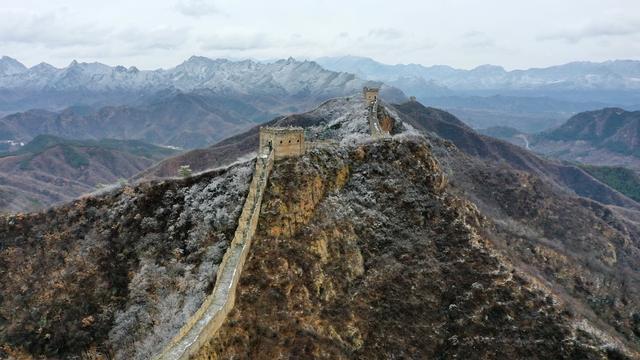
[194,141,623,359]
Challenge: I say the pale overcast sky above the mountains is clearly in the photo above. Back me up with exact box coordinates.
[0,0,640,69]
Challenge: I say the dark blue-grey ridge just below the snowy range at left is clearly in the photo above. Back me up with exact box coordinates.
[0,90,280,148]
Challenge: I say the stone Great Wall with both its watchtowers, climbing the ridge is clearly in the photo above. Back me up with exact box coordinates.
[154,87,389,360]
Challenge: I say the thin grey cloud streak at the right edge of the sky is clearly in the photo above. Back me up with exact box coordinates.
[538,19,640,43]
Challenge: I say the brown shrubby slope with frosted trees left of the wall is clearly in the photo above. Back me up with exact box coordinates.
[0,162,253,359]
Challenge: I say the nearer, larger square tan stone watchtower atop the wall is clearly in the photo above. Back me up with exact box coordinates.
[260,127,304,159]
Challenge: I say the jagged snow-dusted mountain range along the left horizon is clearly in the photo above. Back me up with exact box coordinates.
[0,56,404,105]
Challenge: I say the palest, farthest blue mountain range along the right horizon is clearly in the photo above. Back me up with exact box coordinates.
[316,56,640,95]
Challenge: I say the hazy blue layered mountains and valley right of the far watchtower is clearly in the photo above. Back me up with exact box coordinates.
[317,56,640,132]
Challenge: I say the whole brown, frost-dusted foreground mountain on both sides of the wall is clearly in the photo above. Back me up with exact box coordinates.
[0,98,640,359]
